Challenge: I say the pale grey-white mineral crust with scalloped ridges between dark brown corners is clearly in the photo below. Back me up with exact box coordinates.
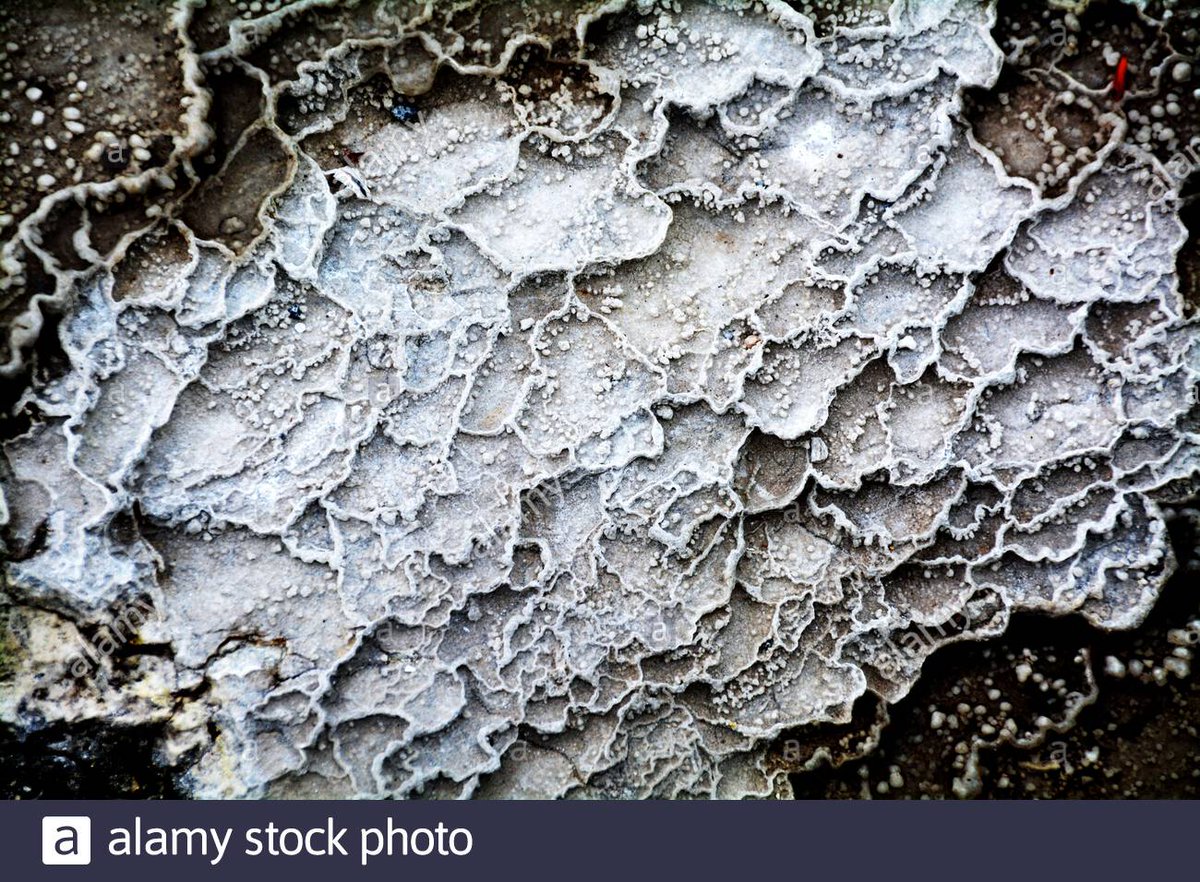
[0,0,1200,797]
